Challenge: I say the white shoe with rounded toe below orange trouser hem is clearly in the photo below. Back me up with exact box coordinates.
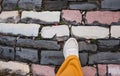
[63,38,79,59]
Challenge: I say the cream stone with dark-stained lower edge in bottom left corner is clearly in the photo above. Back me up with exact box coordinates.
[0,61,29,76]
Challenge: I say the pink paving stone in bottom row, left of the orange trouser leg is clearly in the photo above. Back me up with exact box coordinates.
[32,64,55,76]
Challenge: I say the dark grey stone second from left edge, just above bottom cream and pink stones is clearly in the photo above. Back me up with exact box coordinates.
[16,47,38,63]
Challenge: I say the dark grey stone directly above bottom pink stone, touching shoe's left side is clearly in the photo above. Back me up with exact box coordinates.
[40,50,64,65]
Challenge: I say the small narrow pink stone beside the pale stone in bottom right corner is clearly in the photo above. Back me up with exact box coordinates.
[98,64,107,76]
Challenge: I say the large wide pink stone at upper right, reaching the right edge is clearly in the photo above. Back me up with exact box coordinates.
[86,11,120,24]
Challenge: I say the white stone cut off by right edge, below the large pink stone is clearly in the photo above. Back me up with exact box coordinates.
[111,26,120,38]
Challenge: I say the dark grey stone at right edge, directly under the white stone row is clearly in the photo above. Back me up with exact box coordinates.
[98,39,120,51]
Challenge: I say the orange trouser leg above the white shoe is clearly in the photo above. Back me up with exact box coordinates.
[56,55,83,76]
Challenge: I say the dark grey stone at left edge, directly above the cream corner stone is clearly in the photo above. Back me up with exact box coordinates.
[0,46,14,60]
